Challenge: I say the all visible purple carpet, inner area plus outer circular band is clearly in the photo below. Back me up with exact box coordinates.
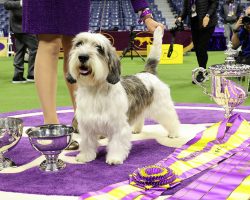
[0,103,250,195]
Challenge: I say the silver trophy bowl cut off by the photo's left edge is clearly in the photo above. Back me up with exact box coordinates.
[0,117,23,171]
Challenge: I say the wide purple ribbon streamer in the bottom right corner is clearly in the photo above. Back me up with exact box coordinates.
[168,147,250,200]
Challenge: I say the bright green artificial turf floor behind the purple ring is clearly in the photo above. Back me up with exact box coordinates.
[0,51,250,113]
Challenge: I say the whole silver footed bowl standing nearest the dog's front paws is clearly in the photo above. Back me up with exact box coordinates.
[26,124,74,172]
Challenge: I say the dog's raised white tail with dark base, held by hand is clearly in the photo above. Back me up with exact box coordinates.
[144,26,163,75]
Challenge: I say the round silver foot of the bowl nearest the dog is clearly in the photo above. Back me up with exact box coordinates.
[39,159,66,172]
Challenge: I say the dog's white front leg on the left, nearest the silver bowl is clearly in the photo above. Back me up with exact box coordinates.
[76,125,98,163]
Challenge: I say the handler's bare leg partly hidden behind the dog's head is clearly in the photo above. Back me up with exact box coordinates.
[62,36,76,111]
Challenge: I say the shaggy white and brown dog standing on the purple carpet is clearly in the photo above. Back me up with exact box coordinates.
[69,27,180,164]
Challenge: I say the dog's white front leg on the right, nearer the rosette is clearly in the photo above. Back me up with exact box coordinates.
[106,124,132,165]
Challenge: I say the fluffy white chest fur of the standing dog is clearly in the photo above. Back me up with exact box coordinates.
[76,85,128,130]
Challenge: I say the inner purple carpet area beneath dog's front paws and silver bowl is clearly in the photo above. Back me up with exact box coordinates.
[0,139,174,195]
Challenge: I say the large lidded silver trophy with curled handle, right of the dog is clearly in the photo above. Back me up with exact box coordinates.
[192,42,250,118]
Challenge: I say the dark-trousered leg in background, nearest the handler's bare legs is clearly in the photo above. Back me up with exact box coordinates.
[23,34,38,78]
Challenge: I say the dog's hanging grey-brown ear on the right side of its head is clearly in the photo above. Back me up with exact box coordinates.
[106,47,121,84]
